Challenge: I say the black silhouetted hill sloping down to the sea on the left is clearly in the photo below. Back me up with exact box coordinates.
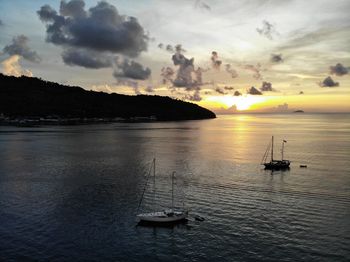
[0,74,216,120]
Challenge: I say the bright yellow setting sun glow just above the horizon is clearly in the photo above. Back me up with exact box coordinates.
[208,95,266,111]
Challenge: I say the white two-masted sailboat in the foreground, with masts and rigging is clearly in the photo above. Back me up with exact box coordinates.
[137,159,188,224]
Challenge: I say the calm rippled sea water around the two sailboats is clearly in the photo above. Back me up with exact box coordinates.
[0,114,350,261]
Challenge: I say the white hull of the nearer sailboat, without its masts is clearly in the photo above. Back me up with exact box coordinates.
[137,210,188,223]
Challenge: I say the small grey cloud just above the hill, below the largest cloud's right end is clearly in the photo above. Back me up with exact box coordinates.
[113,59,151,80]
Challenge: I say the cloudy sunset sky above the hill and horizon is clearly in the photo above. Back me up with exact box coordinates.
[0,0,350,114]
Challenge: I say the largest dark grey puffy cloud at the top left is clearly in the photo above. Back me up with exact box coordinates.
[37,0,149,57]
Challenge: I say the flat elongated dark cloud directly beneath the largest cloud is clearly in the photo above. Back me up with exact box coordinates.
[62,48,113,69]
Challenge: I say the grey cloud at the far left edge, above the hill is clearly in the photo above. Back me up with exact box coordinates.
[3,35,41,63]
